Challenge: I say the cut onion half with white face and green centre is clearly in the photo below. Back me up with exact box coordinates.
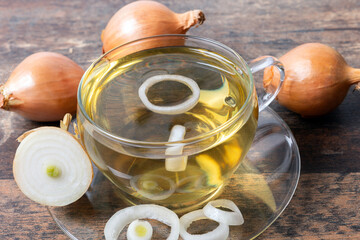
[13,114,93,206]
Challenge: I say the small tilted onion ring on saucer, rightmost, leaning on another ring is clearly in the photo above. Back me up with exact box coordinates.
[203,199,244,225]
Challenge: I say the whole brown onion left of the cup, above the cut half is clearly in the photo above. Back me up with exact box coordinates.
[0,52,84,122]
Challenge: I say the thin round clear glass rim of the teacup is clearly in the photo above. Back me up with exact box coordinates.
[77,34,254,148]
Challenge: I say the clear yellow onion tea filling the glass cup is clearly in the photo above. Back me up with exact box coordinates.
[78,47,258,211]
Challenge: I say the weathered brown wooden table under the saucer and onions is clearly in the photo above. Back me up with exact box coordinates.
[0,0,360,239]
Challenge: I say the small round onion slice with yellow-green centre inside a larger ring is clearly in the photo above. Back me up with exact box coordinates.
[126,220,153,240]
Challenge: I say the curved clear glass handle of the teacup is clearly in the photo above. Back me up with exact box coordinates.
[249,56,285,112]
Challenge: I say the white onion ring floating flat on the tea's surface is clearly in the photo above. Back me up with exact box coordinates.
[138,74,200,115]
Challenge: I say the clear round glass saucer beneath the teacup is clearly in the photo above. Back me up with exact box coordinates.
[48,107,300,240]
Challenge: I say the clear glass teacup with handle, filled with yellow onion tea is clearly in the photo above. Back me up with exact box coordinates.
[77,35,284,212]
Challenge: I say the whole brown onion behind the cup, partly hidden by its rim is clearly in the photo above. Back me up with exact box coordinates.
[101,1,205,52]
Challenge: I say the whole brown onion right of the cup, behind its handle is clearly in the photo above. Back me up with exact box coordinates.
[264,43,360,117]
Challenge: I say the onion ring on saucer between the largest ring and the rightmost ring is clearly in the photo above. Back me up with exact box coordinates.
[180,209,229,240]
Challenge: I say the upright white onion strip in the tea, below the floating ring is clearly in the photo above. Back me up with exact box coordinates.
[165,125,188,172]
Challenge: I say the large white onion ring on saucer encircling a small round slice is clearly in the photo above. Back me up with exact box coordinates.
[104,204,180,240]
